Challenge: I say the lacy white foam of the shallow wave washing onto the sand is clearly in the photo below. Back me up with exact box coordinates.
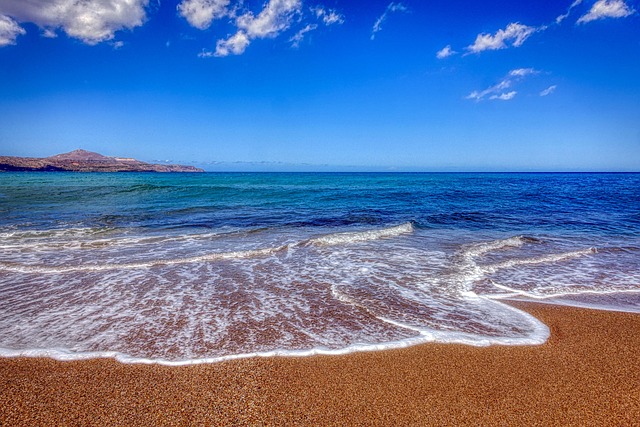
[0,231,632,366]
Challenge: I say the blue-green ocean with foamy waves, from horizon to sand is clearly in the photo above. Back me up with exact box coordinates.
[0,172,640,365]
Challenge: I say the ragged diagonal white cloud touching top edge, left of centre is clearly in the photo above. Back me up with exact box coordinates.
[215,0,302,56]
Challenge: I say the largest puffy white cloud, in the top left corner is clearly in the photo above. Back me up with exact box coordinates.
[0,0,149,44]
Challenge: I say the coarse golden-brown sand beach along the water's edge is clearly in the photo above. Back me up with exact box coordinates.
[0,304,640,427]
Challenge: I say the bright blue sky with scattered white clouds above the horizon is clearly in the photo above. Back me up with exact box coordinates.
[0,0,640,171]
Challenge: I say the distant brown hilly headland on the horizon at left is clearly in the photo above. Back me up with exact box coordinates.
[0,150,204,172]
